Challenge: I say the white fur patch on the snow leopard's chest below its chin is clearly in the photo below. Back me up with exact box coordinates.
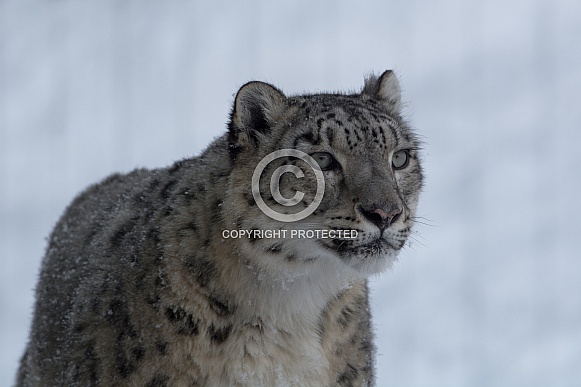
[204,239,357,386]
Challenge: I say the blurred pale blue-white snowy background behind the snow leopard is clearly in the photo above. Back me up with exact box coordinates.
[0,0,581,386]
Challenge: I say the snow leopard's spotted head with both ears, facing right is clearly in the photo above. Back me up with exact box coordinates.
[225,71,422,275]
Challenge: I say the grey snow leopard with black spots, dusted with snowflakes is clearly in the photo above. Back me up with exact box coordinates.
[16,70,423,386]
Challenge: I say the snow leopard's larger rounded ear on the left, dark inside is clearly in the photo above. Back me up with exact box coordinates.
[229,81,286,158]
